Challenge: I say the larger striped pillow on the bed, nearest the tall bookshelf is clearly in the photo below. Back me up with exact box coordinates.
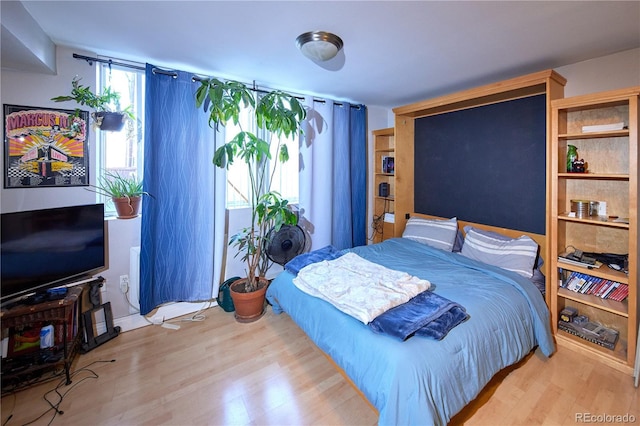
[460,228,538,278]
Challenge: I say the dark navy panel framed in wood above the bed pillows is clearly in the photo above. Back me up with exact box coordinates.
[414,94,546,234]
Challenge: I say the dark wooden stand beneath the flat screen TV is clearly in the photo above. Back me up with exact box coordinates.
[0,286,83,394]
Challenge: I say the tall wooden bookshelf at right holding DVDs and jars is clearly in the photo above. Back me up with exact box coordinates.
[549,87,640,373]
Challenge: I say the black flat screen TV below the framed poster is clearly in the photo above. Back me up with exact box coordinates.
[0,204,106,303]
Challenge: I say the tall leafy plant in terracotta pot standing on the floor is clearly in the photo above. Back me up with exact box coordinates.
[195,78,306,322]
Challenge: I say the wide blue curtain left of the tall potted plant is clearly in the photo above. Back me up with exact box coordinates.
[140,64,216,315]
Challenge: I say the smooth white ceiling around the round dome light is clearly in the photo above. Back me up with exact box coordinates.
[2,1,640,107]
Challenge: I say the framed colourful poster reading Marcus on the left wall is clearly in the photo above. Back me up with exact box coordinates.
[4,104,89,188]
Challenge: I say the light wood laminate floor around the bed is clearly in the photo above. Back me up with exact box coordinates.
[1,308,640,426]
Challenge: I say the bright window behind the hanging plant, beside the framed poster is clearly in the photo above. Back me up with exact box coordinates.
[96,64,145,215]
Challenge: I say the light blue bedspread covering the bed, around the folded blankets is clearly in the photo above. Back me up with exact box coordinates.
[267,218,555,425]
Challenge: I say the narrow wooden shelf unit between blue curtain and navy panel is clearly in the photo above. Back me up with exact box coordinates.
[371,127,396,243]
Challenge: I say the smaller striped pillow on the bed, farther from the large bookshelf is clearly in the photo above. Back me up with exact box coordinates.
[402,217,458,251]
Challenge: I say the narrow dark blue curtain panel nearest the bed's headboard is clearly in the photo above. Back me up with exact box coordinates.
[331,102,367,249]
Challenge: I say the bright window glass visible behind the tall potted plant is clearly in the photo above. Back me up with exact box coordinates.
[225,97,299,209]
